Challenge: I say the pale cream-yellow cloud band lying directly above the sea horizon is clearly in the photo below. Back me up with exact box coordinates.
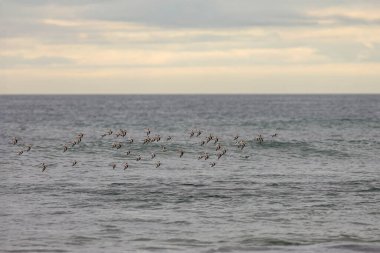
[0,64,380,94]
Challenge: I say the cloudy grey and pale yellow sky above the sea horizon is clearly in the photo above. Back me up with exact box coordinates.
[0,0,380,94]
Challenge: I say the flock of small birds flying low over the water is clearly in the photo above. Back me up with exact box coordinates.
[10,128,278,172]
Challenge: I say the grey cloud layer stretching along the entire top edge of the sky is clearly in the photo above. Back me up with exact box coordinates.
[0,0,380,28]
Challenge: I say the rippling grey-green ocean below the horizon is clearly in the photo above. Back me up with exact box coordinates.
[0,95,380,253]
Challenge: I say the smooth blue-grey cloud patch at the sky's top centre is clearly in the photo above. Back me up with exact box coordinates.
[84,0,315,28]
